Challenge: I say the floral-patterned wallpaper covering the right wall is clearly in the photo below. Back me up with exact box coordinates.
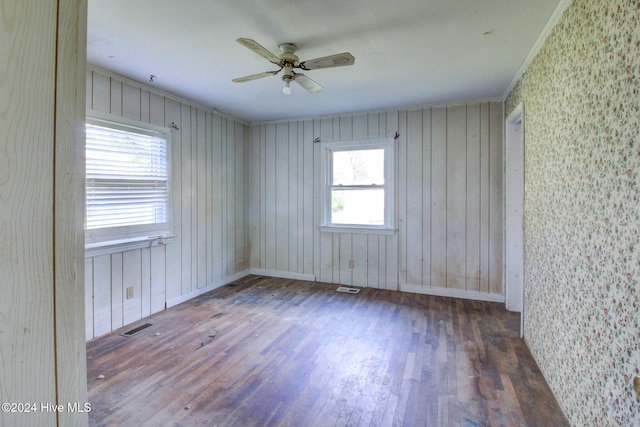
[505,0,640,426]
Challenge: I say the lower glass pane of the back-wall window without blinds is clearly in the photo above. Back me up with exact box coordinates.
[331,188,384,225]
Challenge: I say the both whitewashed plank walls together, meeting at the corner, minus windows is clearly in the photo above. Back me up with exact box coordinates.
[85,68,504,339]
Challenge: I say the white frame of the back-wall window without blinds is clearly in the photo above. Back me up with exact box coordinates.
[320,138,396,234]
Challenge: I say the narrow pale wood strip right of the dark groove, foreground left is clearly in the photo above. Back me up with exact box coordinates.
[55,0,88,427]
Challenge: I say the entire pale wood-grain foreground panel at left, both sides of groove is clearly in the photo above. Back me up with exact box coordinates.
[0,0,87,426]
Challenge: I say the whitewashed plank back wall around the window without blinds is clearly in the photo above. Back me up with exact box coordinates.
[248,102,504,301]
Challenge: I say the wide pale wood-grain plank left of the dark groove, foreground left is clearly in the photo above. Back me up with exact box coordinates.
[0,1,57,426]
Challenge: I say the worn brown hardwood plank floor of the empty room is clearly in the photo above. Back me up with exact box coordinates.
[87,276,568,427]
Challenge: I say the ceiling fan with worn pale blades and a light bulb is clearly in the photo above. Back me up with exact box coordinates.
[232,38,356,95]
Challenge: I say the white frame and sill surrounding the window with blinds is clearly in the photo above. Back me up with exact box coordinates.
[84,111,175,256]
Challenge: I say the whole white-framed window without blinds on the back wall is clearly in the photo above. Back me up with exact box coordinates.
[323,139,394,232]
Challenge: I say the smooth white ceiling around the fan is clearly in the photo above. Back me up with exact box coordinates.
[87,0,561,122]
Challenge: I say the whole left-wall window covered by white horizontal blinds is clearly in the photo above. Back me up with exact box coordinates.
[85,118,170,248]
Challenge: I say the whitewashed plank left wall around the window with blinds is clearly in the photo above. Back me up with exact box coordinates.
[85,67,249,339]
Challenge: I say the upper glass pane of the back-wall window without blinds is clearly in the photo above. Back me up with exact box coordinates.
[332,149,384,185]
